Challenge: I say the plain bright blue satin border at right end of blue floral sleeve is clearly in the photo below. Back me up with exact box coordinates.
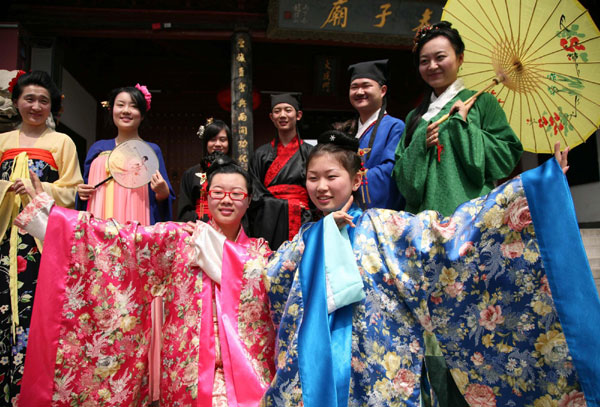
[521,159,600,406]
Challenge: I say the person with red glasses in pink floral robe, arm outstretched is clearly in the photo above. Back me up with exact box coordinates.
[17,157,275,407]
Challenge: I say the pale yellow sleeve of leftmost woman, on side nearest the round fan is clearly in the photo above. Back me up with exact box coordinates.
[38,135,83,208]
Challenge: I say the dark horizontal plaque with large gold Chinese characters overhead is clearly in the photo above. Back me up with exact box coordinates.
[268,0,445,46]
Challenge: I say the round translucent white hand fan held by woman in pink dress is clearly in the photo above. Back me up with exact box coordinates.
[95,140,158,188]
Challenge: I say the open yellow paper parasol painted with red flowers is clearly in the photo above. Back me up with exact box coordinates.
[442,0,600,153]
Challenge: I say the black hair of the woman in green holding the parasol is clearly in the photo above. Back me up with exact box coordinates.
[404,21,465,147]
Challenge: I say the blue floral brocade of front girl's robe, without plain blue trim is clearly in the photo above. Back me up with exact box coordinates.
[263,169,589,407]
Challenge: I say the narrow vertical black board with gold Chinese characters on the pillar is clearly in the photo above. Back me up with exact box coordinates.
[231,32,252,170]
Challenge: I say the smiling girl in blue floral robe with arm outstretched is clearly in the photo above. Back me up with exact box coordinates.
[263,131,600,407]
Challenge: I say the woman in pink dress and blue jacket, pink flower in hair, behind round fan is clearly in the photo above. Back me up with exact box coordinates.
[76,84,175,400]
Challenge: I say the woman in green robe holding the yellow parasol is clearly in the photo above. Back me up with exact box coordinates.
[392,21,523,216]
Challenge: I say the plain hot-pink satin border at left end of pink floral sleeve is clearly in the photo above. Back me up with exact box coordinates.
[19,206,78,407]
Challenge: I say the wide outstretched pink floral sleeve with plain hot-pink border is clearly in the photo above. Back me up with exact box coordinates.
[20,206,192,407]
